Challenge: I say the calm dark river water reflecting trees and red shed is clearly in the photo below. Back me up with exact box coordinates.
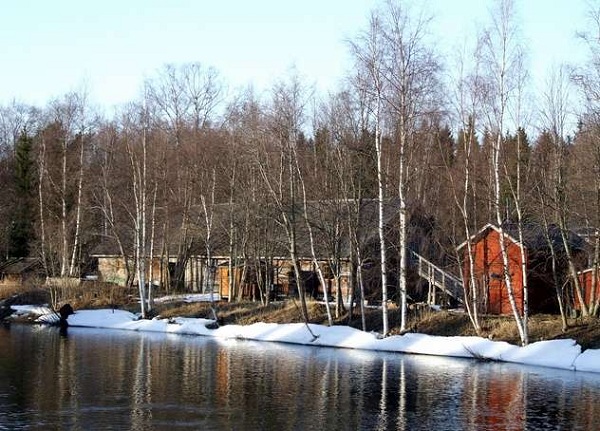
[0,325,600,431]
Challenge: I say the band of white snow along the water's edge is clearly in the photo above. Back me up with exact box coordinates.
[8,306,600,373]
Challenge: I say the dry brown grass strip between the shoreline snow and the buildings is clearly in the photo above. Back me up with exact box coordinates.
[0,283,600,350]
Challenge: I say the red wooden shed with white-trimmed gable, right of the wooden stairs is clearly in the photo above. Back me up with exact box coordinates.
[458,224,585,314]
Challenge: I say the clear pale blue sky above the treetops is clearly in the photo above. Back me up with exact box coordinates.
[0,0,586,108]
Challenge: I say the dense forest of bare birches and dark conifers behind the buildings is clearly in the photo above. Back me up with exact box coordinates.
[0,1,600,341]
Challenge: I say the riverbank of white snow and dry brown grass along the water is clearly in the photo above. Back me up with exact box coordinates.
[3,288,600,373]
